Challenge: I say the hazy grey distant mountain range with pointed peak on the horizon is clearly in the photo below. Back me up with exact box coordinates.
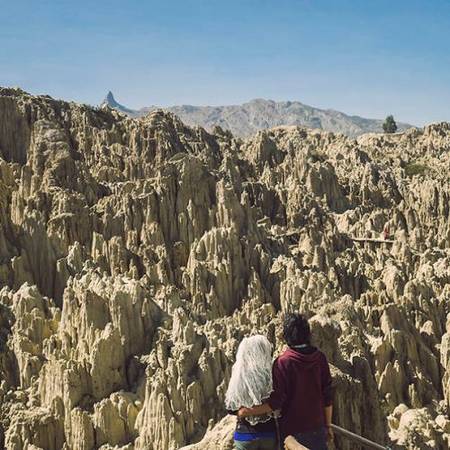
[101,91,412,137]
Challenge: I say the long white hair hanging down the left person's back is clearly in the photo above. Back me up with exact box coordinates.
[225,334,273,425]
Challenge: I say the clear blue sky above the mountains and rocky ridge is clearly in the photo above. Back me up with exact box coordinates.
[0,0,450,125]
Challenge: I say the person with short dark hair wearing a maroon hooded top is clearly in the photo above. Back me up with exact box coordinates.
[238,313,333,450]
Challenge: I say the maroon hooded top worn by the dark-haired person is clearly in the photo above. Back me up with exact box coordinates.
[268,347,332,436]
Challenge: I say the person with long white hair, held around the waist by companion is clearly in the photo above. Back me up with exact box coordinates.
[225,335,277,450]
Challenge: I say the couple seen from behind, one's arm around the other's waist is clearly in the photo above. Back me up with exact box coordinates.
[225,314,333,450]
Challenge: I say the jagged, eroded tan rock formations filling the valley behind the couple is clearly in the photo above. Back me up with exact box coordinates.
[0,89,450,450]
